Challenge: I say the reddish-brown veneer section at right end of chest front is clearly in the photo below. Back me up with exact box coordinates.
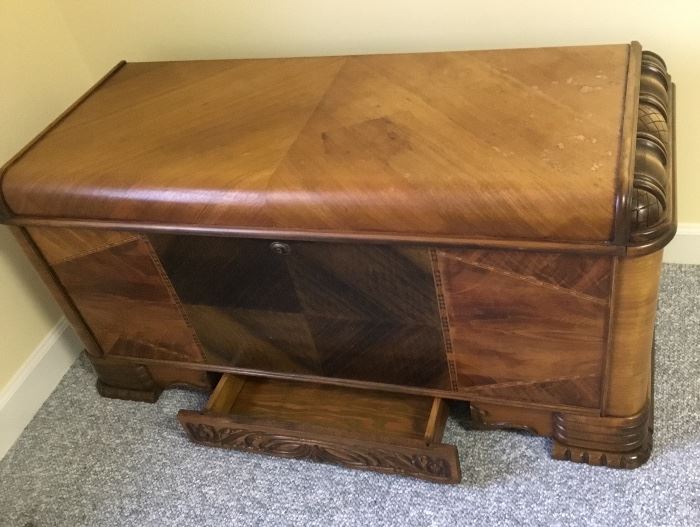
[438,250,612,408]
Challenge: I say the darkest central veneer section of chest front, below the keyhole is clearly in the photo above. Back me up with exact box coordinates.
[150,235,449,389]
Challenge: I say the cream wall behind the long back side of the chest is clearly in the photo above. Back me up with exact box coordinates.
[58,0,700,223]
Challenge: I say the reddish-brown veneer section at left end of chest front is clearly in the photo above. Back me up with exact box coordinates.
[31,228,203,362]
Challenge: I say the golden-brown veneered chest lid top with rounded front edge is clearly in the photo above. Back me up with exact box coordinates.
[1,45,638,243]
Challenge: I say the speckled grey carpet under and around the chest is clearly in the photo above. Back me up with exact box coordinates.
[0,265,700,527]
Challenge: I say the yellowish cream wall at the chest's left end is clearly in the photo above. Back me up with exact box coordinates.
[0,0,92,391]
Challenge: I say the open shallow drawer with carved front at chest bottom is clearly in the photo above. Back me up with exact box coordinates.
[178,374,461,483]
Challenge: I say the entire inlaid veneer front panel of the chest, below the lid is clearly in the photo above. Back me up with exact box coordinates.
[29,228,612,408]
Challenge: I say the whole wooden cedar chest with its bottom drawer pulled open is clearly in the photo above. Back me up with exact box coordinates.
[0,43,676,481]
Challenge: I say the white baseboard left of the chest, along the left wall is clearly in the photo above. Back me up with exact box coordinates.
[0,318,83,459]
